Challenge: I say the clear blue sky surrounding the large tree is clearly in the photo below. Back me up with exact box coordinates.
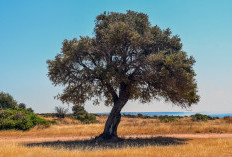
[0,0,232,112]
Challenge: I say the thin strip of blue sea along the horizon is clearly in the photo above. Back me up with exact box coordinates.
[96,112,232,118]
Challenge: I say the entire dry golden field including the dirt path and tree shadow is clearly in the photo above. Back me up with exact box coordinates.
[0,116,232,157]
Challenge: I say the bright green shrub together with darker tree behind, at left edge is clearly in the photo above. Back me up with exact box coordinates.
[0,92,51,131]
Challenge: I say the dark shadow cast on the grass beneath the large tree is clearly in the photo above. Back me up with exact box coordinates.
[26,136,190,149]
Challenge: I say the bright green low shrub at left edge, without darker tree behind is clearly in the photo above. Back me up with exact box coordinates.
[0,109,50,131]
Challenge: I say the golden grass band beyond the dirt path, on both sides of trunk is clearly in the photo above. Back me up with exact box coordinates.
[0,116,232,137]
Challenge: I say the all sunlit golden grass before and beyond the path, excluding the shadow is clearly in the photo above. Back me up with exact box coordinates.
[0,116,232,157]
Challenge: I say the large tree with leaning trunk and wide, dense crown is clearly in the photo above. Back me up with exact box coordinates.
[47,11,199,139]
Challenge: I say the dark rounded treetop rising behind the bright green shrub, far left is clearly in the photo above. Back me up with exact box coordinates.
[0,92,17,109]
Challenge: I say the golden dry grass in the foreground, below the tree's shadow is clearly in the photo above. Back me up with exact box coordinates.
[0,138,232,157]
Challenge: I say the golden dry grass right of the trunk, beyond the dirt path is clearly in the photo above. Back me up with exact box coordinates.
[118,118,232,135]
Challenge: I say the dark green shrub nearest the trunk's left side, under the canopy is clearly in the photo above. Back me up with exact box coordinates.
[72,105,97,124]
